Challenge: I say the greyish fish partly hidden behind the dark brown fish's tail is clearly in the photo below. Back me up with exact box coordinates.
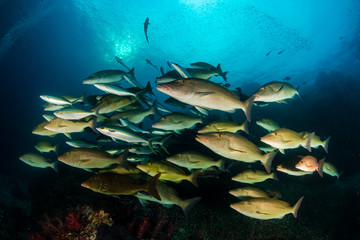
[136,182,201,219]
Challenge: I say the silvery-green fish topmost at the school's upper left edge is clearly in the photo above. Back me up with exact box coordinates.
[83,68,134,84]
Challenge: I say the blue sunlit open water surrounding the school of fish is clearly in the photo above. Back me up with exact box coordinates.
[0,0,360,239]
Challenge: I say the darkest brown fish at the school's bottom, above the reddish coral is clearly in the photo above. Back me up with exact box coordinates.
[81,172,161,200]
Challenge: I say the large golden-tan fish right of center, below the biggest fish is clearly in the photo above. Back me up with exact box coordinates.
[195,132,277,173]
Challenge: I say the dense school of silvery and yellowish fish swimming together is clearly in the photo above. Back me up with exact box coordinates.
[20,46,340,219]
